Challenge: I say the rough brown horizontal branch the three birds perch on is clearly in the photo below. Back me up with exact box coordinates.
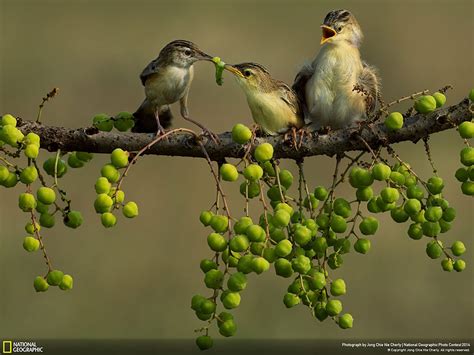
[18,99,473,161]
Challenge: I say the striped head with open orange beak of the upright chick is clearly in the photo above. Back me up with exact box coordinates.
[321,10,363,47]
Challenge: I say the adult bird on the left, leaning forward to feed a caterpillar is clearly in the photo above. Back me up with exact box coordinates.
[132,40,216,139]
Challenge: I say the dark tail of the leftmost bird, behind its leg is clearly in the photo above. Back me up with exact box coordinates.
[132,100,173,133]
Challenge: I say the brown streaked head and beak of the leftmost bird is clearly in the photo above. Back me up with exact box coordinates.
[159,39,212,67]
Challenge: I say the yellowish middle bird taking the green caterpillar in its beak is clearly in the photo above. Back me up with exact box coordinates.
[224,62,304,135]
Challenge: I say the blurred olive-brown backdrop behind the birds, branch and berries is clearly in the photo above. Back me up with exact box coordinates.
[0,0,474,348]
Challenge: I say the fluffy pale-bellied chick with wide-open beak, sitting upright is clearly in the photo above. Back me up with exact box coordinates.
[292,10,380,129]
